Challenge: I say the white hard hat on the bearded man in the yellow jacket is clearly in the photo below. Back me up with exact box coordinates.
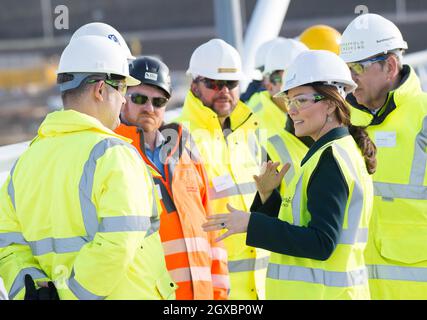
[187,39,245,80]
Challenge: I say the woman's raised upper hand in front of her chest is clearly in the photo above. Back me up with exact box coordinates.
[253,161,291,203]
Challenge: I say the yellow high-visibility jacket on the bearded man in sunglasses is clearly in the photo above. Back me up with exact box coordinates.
[178,92,268,299]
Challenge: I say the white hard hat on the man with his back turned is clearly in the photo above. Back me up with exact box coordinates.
[57,36,141,91]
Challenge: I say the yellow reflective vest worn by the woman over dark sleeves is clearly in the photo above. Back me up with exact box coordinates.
[266,136,373,299]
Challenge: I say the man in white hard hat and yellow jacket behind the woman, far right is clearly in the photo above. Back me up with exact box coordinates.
[340,14,427,299]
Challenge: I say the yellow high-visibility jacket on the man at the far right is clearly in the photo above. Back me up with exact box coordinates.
[352,66,427,299]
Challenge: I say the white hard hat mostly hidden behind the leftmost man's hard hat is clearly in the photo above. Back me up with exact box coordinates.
[70,22,135,61]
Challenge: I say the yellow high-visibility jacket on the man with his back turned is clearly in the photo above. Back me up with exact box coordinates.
[0,110,176,299]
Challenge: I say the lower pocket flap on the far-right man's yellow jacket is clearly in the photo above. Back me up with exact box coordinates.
[381,235,427,264]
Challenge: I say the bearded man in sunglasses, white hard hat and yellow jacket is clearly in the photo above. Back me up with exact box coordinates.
[179,39,269,299]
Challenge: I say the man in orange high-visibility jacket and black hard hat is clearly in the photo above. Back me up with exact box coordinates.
[116,56,229,300]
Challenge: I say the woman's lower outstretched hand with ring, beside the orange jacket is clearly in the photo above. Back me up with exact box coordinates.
[202,204,251,242]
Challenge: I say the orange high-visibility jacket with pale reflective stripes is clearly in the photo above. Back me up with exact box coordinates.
[116,124,230,300]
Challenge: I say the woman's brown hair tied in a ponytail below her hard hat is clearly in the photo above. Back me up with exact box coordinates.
[313,84,377,174]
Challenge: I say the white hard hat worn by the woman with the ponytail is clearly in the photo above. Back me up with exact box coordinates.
[282,50,357,94]
